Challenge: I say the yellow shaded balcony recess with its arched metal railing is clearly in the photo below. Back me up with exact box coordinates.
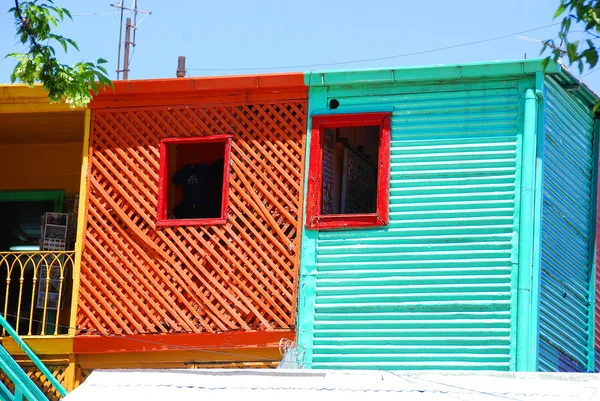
[0,93,89,338]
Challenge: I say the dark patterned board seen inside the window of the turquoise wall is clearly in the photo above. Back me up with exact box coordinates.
[342,148,377,214]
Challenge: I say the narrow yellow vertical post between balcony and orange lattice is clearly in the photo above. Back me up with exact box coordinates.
[69,109,92,335]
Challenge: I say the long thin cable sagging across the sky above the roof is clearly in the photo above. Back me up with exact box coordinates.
[188,22,560,71]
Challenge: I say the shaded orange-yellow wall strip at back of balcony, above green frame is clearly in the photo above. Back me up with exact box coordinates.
[0,142,83,192]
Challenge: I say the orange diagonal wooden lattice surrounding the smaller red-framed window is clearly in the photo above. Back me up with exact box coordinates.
[77,101,306,334]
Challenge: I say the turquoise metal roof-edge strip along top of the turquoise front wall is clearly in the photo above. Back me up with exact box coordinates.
[306,59,561,87]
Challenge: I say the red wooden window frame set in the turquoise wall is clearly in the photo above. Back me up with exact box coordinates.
[306,113,391,229]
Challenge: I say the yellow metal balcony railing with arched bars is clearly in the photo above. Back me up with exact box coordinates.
[0,251,75,336]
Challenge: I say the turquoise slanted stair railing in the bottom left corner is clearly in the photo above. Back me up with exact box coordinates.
[0,315,67,401]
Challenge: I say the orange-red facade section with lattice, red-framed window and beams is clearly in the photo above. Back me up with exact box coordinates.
[74,74,307,368]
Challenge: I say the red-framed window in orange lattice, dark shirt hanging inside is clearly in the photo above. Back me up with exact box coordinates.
[156,135,233,226]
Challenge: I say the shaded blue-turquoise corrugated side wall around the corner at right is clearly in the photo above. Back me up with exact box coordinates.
[539,79,595,371]
